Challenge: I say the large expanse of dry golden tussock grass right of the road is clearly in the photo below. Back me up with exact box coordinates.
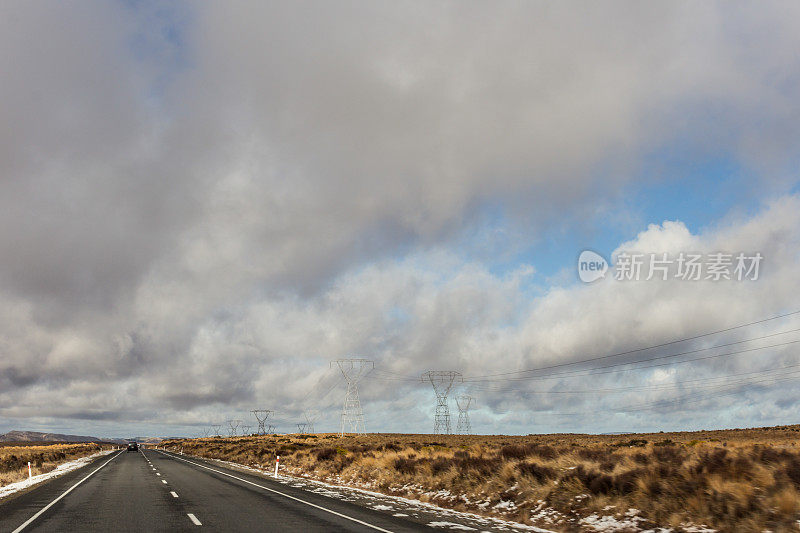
[164,426,800,532]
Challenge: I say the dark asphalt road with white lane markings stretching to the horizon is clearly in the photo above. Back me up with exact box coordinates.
[0,450,433,533]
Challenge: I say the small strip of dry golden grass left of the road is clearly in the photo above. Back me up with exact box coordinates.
[0,443,106,487]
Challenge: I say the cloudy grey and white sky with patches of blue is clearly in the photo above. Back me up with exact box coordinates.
[0,1,800,437]
